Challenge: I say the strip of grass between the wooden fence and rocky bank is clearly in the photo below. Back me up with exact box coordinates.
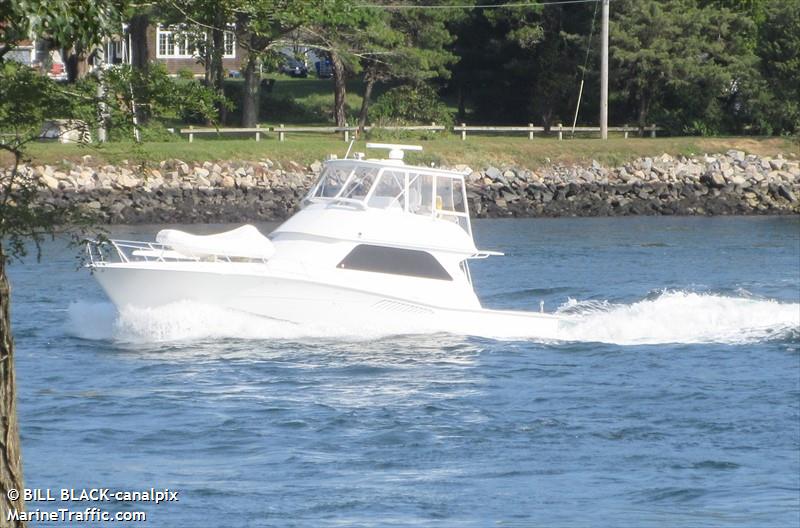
[9,134,800,168]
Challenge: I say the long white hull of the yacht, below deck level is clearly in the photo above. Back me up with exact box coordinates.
[93,265,561,339]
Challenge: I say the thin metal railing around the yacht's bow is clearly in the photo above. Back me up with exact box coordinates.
[86,239,267,266]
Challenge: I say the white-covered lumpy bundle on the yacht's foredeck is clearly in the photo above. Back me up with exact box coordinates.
[156,225,275,259]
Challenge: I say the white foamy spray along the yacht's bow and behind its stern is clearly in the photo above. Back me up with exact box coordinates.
[67,291,800,345]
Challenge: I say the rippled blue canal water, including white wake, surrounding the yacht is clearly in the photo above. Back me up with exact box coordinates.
[10,217,800,527]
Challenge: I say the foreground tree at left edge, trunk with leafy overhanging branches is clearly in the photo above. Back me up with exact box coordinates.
[0,7,222,527]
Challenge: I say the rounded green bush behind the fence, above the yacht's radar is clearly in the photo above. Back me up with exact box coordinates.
[373,84,453,125]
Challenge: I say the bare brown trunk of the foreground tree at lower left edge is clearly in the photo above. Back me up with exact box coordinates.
[0,246,25,527]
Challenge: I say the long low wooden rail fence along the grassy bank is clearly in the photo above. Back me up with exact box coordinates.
[180,123,661,143]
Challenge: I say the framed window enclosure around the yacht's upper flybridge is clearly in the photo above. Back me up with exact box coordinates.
[308,161,471,234]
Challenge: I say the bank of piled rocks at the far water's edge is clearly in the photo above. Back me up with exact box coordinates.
[17,150,800,224]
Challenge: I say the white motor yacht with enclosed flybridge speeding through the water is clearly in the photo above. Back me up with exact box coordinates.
[87,144,560,339]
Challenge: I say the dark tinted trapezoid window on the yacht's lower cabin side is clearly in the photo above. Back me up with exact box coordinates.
[337,244,453,280]
